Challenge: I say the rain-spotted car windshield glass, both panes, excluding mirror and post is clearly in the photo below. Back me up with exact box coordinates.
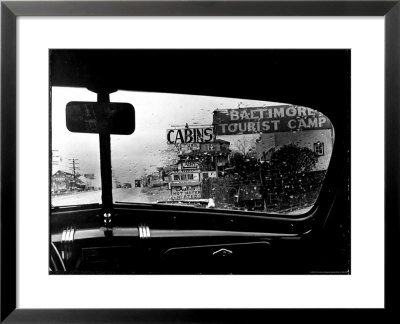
[51,87,334,215]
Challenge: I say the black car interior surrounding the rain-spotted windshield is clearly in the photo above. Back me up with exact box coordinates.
[49,49,351,275]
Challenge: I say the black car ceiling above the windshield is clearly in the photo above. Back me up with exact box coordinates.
[50,50,350,110]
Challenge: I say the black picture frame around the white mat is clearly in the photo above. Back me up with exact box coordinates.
[0,0,400,323]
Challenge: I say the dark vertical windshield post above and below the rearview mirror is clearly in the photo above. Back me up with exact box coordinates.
[97,93,113,212]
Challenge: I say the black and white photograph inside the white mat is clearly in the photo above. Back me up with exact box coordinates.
[49,49,351,275]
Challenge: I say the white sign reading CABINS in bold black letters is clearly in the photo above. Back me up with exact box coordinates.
[167,127,214,144]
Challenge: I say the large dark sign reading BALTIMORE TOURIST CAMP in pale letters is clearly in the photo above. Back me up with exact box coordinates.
[213,105,332,135]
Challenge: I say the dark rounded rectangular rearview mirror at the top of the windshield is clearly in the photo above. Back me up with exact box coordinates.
[66,101,135,135]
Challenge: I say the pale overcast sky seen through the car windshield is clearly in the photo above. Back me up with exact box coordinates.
[51,87,281,183]
